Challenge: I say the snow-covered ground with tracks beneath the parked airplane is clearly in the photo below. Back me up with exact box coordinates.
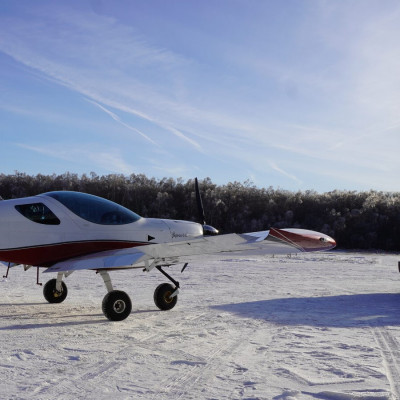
[0,251,400,400]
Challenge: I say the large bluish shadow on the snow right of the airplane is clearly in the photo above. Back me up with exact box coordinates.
[212,293,400,328]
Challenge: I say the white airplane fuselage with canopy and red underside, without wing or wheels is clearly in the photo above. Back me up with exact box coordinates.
[0,192,203,267]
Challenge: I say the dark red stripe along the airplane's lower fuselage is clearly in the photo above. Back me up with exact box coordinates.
[0,240,147,267]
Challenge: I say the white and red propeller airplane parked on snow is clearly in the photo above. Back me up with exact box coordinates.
[0,179,336,321]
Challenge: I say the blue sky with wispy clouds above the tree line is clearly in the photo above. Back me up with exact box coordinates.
[0,0,400,192]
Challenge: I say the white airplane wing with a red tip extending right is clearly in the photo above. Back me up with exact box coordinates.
[45,228,336,272]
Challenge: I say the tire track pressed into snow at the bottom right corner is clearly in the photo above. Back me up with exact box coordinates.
[373,327,400,399]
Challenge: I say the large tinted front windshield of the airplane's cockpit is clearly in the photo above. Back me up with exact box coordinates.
[44,191,140,225]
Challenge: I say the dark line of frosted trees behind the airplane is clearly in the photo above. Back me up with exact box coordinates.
[0,172,400,251]
